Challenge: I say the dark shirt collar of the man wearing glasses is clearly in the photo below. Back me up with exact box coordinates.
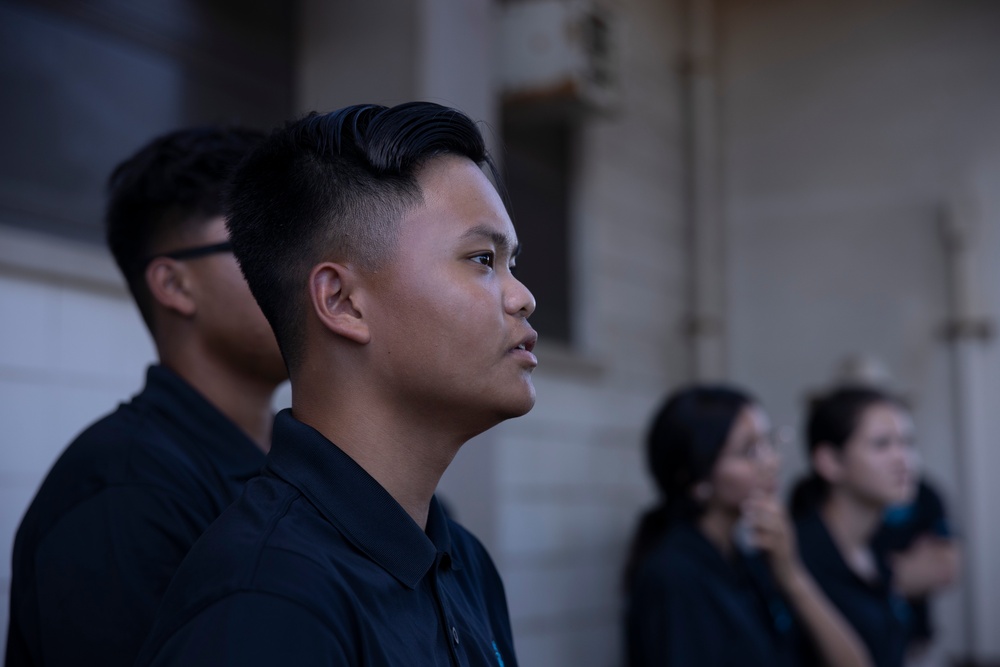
[140,365,264,481]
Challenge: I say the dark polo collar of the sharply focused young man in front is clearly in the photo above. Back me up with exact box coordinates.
[267,409,460,589]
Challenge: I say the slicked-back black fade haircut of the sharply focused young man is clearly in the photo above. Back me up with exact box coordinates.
[227,102,496,370]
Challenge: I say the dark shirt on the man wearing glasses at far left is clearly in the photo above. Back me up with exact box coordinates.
[6,366,264,667]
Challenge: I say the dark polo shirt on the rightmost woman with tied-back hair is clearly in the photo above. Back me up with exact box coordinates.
[795,511,907,667]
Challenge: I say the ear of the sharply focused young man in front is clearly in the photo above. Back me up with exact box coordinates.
[309,262,371,345]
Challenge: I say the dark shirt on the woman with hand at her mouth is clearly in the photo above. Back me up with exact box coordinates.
[626,522,797,667]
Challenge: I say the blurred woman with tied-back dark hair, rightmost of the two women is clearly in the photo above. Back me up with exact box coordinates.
[791,387,915,667]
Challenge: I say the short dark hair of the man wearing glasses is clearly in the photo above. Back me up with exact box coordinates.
[104,126,265,335]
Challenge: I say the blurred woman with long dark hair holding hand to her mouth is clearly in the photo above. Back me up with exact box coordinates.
[625,386,870,667]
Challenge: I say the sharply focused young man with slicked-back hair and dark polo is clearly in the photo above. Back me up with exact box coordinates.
[137,103,537,667]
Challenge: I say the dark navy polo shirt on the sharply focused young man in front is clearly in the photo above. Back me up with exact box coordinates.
[137,410,517,667]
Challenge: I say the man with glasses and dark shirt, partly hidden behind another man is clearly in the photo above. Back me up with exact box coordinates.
[6,127,287,667]
